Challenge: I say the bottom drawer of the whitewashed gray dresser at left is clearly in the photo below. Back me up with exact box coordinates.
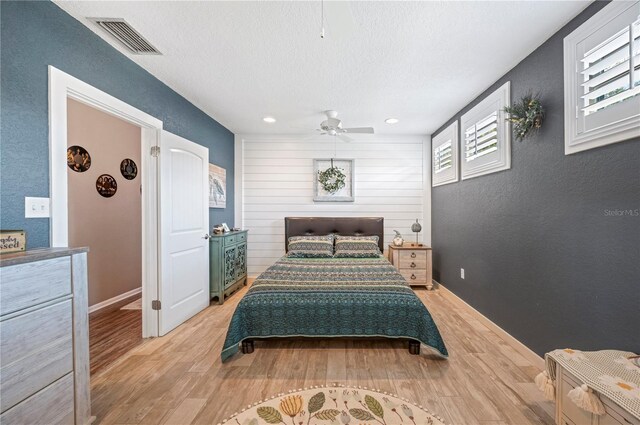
[0,373,75,425]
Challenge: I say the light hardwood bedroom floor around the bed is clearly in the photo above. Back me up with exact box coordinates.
[91,288,553,425]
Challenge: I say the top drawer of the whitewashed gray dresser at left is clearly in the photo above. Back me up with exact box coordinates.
[0,257,71,315]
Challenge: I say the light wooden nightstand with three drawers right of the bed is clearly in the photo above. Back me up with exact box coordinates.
[389,244,433,290]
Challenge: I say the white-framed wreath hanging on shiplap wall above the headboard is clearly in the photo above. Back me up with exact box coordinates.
[313,158,355,202]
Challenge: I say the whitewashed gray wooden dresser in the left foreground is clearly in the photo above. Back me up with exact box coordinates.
[0,248,91,425]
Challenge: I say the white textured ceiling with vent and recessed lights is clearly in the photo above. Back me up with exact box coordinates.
[56,1,588,134]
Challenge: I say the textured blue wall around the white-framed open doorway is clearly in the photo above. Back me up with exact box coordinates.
[0,1,234,248]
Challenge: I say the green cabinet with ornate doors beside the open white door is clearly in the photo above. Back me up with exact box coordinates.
[209,230,248,304]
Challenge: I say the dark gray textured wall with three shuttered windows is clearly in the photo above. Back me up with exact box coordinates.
[432,2,640,355]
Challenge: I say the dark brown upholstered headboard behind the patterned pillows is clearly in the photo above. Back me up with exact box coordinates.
[284,217,384,252]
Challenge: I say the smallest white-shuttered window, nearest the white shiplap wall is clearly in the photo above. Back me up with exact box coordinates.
[431,121,458,187]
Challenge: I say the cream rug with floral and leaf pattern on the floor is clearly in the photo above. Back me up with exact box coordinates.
[218,386,444,425]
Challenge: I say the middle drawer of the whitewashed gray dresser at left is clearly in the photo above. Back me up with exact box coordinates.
[0,299,73,412]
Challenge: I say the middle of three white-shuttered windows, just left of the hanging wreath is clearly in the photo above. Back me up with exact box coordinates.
[461,82,511,180]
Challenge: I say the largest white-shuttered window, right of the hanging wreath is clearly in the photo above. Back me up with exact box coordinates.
[564,1,640,154]
